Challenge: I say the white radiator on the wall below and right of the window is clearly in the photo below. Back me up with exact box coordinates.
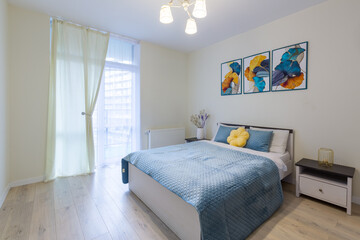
[146,128,185,149]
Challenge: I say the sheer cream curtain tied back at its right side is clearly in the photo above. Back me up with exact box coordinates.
[45,19,109,181]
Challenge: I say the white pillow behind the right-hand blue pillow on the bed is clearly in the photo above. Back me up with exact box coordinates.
[250,127,289,154]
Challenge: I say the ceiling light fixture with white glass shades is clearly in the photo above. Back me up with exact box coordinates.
[160,0,207,34]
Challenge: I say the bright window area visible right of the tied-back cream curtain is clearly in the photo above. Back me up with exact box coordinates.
[93,36,140,167]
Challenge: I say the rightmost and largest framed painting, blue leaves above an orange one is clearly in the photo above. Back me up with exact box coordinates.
[271,42,308,92]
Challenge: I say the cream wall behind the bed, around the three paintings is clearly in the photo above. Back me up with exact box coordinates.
[187,0,360,201]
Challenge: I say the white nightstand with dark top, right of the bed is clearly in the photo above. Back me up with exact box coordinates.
[295,158,355,215]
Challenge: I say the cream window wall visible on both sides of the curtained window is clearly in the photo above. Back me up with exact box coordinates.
[9,5,187,182]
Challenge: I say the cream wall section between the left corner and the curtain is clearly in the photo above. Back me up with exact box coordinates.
[9,5,50,182]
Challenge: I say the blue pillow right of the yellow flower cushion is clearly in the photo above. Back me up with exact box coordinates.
[245,129,273,152]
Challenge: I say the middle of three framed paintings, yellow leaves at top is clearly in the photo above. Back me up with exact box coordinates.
[244,51,270,94]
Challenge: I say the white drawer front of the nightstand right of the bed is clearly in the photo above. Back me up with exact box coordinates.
[300,176,347,207]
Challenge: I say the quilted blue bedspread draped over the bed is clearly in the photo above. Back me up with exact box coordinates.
[122,141,283,240]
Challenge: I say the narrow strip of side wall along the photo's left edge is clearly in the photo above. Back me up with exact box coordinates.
[0,0,9,199]
